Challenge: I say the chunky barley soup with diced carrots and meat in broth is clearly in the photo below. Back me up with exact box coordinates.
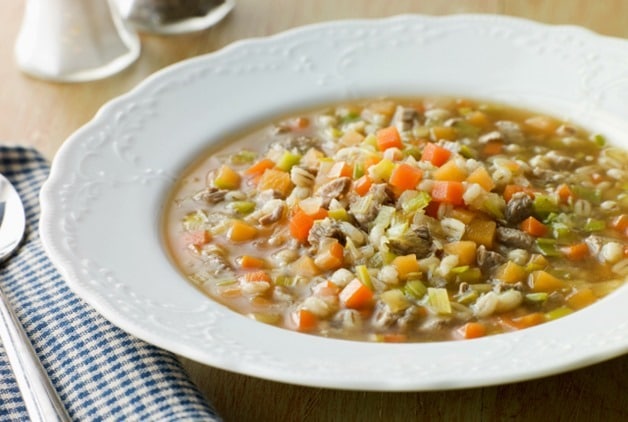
[165,98,628,342]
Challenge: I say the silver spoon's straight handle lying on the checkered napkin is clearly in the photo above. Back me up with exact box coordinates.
[0,290,71,422]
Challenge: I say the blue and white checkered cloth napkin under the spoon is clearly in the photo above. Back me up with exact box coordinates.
[0,146,220,421]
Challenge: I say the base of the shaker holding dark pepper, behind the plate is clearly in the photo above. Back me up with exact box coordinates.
[118,0,235,34]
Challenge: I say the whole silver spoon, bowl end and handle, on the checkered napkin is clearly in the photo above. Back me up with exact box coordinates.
[0,174,71,421]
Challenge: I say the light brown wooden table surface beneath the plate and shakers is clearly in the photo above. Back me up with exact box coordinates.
[0,0,628,422]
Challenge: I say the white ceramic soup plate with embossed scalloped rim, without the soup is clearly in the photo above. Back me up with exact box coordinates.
[41,15,628,391]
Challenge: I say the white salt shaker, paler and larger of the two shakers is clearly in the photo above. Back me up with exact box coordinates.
[15,0,140,82]
